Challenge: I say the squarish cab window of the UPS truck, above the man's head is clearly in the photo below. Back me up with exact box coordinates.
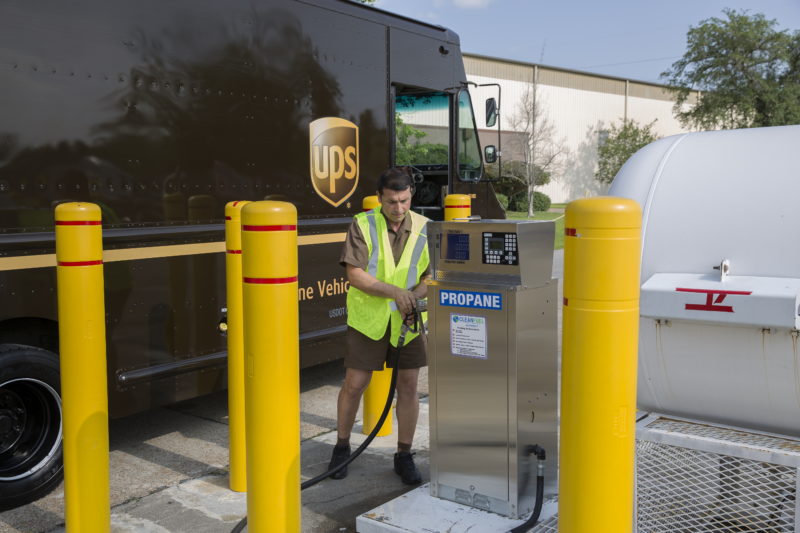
[394,92,450,168]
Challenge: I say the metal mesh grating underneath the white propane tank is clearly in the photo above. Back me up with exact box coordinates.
[636,419,798,533]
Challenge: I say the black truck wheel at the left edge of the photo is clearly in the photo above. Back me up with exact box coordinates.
[0,344,64,511]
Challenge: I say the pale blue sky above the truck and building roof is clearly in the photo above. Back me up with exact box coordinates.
[375,0,800,83]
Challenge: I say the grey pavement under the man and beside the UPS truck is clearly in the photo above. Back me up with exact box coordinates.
[0,250,563,533]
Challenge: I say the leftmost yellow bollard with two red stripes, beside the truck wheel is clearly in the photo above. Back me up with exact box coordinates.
[55,202,111,533]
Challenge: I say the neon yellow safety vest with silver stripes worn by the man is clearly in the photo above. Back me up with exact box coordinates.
[347,206,430,347]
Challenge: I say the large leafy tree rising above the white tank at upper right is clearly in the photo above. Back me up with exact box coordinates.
[661,9,800,129]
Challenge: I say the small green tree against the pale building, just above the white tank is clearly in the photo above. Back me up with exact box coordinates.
[595,120,658,183]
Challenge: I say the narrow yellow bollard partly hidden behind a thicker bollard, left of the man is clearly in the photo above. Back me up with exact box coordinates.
[225,201,249,492]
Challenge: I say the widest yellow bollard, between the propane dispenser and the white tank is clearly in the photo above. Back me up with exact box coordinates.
[558,197,642,533]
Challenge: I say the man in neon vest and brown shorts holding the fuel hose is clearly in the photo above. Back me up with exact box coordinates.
[329,167,429,485]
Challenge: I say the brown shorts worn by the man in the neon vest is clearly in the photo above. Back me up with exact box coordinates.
[344,325,428,370]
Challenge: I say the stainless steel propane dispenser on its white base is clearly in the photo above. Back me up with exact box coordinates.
[357,220,558,533]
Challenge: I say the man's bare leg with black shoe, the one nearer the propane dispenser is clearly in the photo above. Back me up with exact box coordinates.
[394,368,422,485]
